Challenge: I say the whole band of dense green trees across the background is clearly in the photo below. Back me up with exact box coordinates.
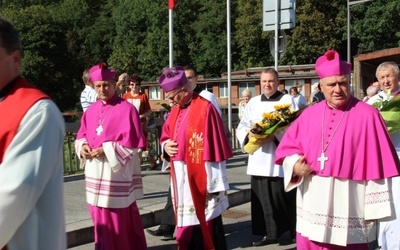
[0,0,400,111]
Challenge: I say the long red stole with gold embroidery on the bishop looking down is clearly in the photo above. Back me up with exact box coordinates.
[169,93,215,249]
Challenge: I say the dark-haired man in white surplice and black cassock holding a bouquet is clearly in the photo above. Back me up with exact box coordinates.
[237,69,297,246]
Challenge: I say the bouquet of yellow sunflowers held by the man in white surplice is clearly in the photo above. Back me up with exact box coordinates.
[244,103,299,154]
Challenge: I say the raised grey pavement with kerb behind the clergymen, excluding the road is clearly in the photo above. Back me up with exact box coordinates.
[64,153,250,247]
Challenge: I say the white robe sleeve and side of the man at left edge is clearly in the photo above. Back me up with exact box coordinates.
[0,100,66,249]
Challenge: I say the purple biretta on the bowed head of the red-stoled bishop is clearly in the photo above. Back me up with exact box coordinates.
[158,66,187,92]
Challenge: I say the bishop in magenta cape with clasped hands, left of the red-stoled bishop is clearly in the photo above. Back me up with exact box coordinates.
[75,64,146,249]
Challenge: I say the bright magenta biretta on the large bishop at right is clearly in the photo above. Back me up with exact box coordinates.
[315,50,351,79]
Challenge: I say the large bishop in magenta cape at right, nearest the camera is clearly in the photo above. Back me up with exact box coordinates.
[276,50,399,250]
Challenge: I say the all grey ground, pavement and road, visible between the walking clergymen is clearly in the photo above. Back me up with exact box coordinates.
[64,153,296,250]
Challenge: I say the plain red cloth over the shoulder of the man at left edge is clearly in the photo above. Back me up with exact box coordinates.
[0,77,50,163]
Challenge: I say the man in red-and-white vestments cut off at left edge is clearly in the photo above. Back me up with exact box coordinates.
[0,18,66,250]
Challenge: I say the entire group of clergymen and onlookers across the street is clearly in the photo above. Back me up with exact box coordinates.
[0,15,400,250]
